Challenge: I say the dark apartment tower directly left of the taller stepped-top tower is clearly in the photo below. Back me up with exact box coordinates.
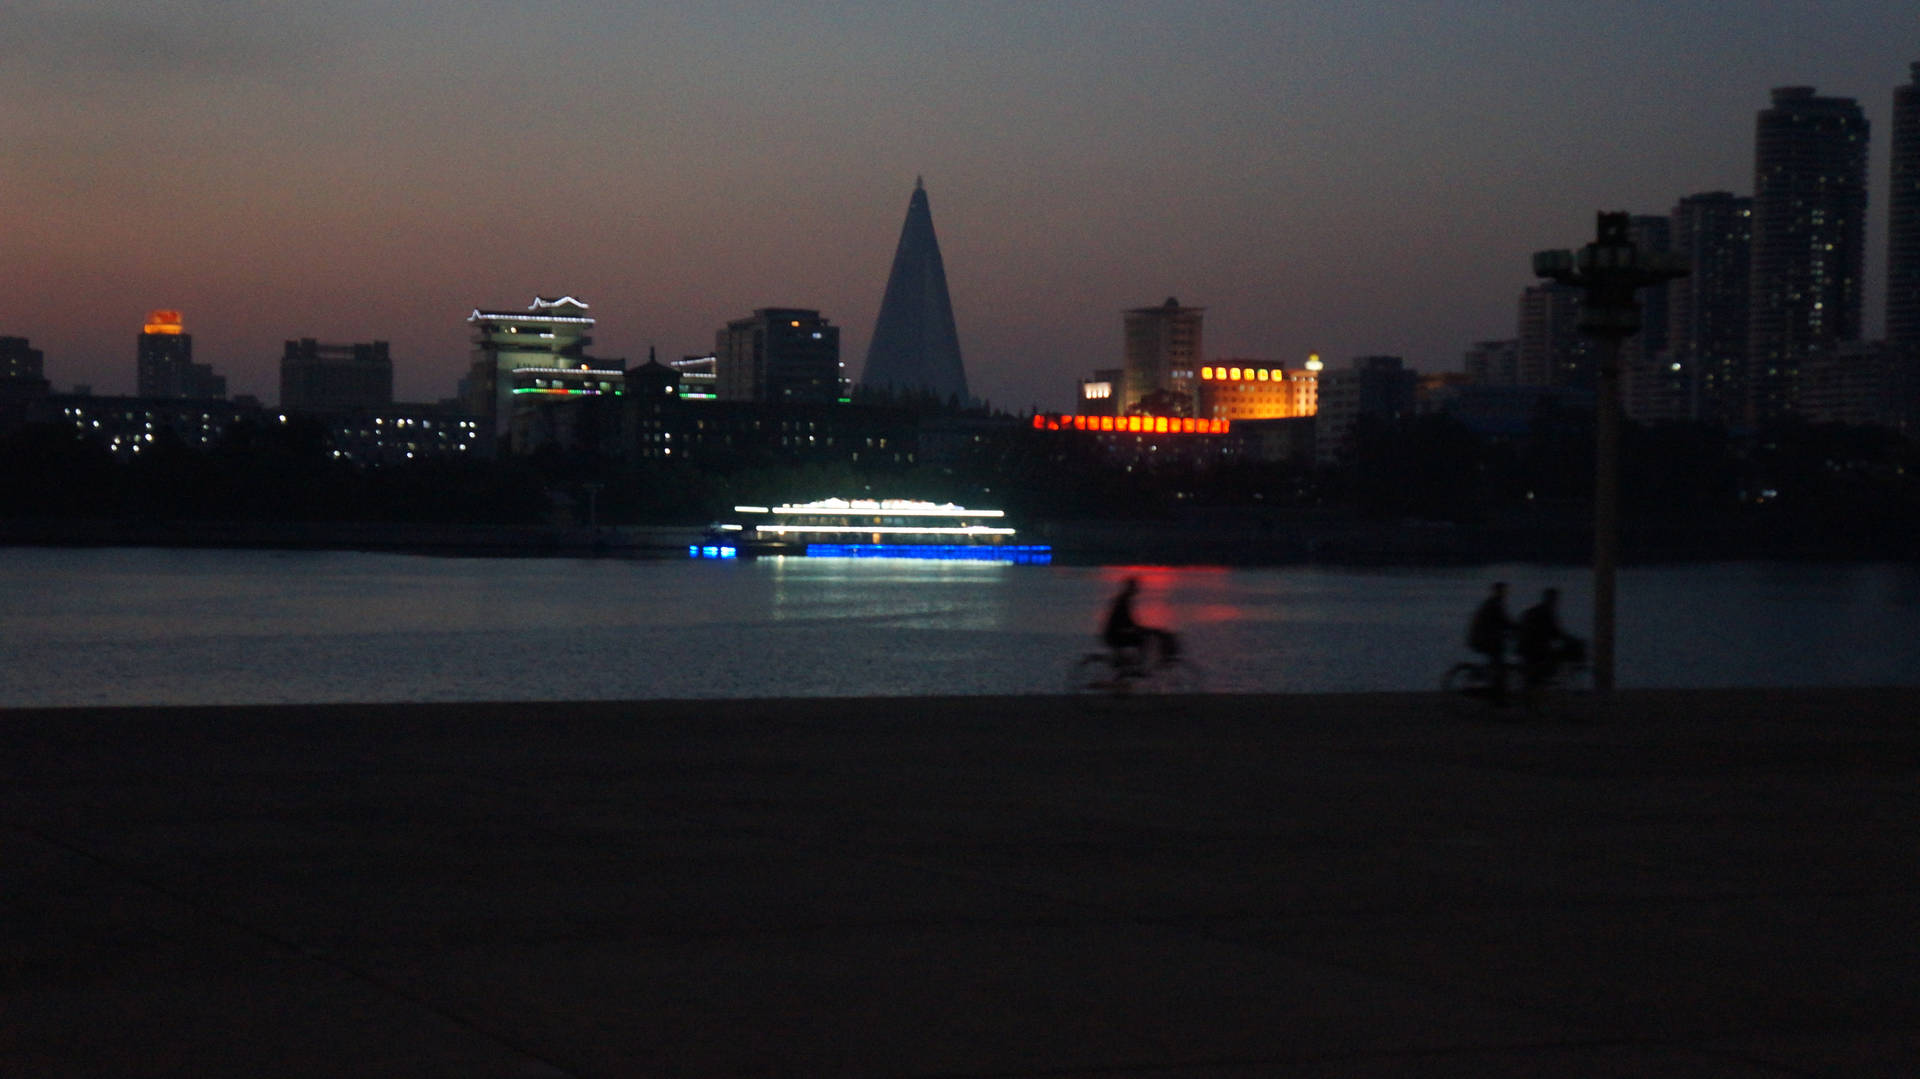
[1667,192,1753,426]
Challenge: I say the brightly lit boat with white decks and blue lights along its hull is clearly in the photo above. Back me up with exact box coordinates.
[687,499,1052,564]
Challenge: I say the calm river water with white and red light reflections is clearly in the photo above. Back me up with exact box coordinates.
[0,549,1920,707]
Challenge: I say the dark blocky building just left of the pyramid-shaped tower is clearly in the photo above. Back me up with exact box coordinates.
[714,307,845,403]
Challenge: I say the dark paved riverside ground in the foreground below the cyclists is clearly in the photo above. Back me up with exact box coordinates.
[0,689,1920,1079]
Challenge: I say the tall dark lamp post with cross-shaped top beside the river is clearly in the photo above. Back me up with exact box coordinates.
[1534,213,1688,697]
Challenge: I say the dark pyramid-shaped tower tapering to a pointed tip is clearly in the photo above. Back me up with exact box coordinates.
[860,180,968,403]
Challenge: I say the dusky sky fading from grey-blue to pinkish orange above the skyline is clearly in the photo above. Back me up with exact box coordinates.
[0,0,1920,409]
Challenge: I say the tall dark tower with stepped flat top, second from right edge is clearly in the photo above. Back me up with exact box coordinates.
[1747,86,1866,422]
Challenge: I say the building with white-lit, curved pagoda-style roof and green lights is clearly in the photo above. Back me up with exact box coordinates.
[465,296,599,437]
